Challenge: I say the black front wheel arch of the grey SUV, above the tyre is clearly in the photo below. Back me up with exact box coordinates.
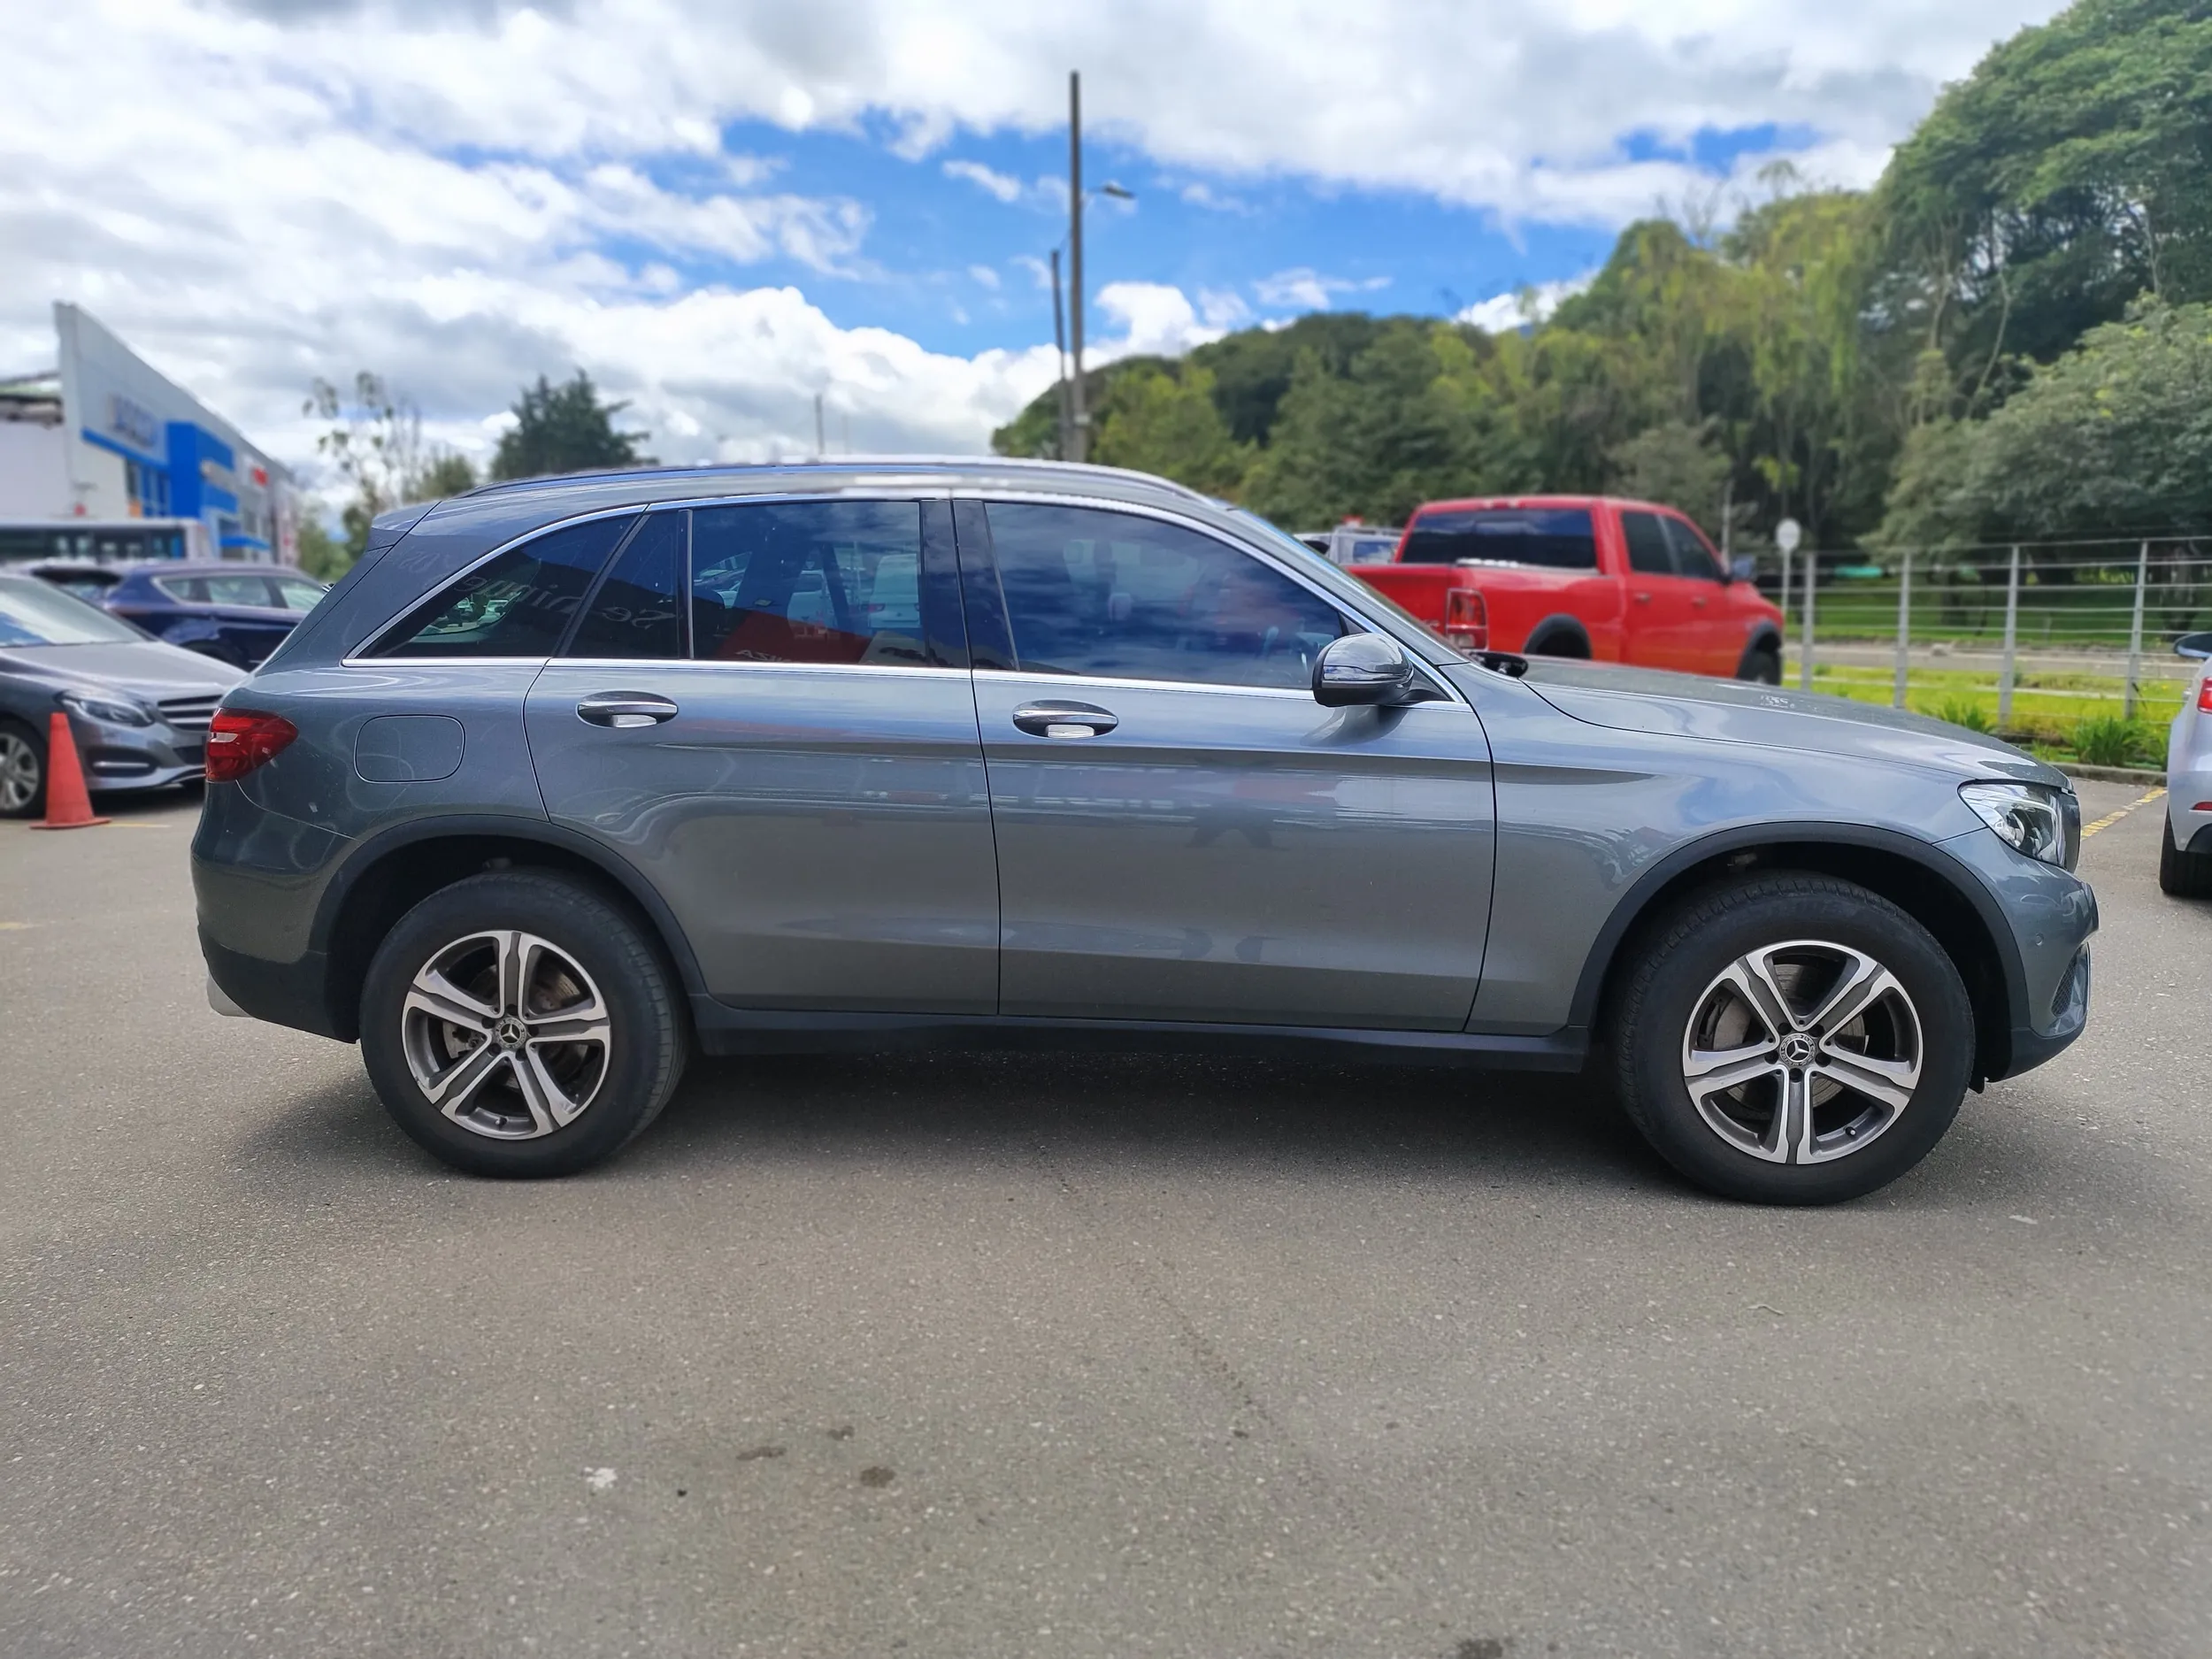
[1569,826,2029,1087]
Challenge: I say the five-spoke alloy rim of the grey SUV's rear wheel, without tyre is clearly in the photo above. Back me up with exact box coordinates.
[401,929,613,1141]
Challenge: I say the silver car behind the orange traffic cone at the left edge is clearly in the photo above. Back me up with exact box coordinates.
[0,573,243,818]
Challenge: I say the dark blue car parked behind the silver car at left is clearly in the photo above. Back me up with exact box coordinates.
[31,560,326,668]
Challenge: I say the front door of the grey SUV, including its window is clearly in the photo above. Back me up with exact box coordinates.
[958,503,1494,1031]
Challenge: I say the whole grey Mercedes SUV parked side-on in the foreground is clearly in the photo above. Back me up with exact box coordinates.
[193,460,2097,1203]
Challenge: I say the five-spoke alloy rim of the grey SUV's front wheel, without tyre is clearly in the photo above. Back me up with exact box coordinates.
[1681,941,1923,1164]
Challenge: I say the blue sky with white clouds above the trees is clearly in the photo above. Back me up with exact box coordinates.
[0,0,2057,500]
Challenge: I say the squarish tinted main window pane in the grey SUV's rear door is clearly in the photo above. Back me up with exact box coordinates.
[690,503,929,664]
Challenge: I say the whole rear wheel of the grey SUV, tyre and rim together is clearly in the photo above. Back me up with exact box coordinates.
[361,872,690,1177]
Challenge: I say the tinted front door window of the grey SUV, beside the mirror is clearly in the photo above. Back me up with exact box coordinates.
[989,503,1343,690]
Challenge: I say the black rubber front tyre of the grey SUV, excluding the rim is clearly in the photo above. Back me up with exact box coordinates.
[1619,876,1976,1203]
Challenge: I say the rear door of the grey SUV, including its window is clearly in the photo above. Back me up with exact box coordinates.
[529,500,998,1016]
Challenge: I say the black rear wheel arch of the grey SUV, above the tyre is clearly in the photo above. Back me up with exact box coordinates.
[308,814,706,1042]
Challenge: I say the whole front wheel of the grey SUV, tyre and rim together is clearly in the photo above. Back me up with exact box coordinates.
[1609,872,1976,1203]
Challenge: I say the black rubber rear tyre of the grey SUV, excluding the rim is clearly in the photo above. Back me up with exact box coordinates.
[361,874,686,1179]
